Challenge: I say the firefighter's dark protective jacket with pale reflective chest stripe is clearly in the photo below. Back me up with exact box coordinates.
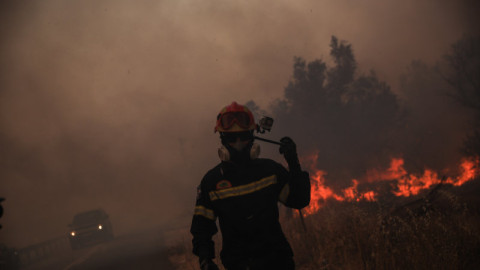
[190,159,310,265]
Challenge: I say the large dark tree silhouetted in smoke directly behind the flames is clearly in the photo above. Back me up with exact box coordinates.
[260,36,401,186]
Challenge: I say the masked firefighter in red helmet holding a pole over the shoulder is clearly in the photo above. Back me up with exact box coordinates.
[190,102,310,270]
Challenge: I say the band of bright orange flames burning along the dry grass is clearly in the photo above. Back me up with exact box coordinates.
[302,155,480,216]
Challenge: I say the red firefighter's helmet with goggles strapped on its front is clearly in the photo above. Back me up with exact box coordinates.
[215,101,257,132]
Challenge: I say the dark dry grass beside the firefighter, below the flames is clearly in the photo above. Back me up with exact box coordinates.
[171,182,480,270]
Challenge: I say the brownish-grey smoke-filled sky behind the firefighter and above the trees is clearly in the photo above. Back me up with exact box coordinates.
[0,0,478,247]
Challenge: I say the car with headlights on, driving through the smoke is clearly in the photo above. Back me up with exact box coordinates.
[68,209,114,249]
